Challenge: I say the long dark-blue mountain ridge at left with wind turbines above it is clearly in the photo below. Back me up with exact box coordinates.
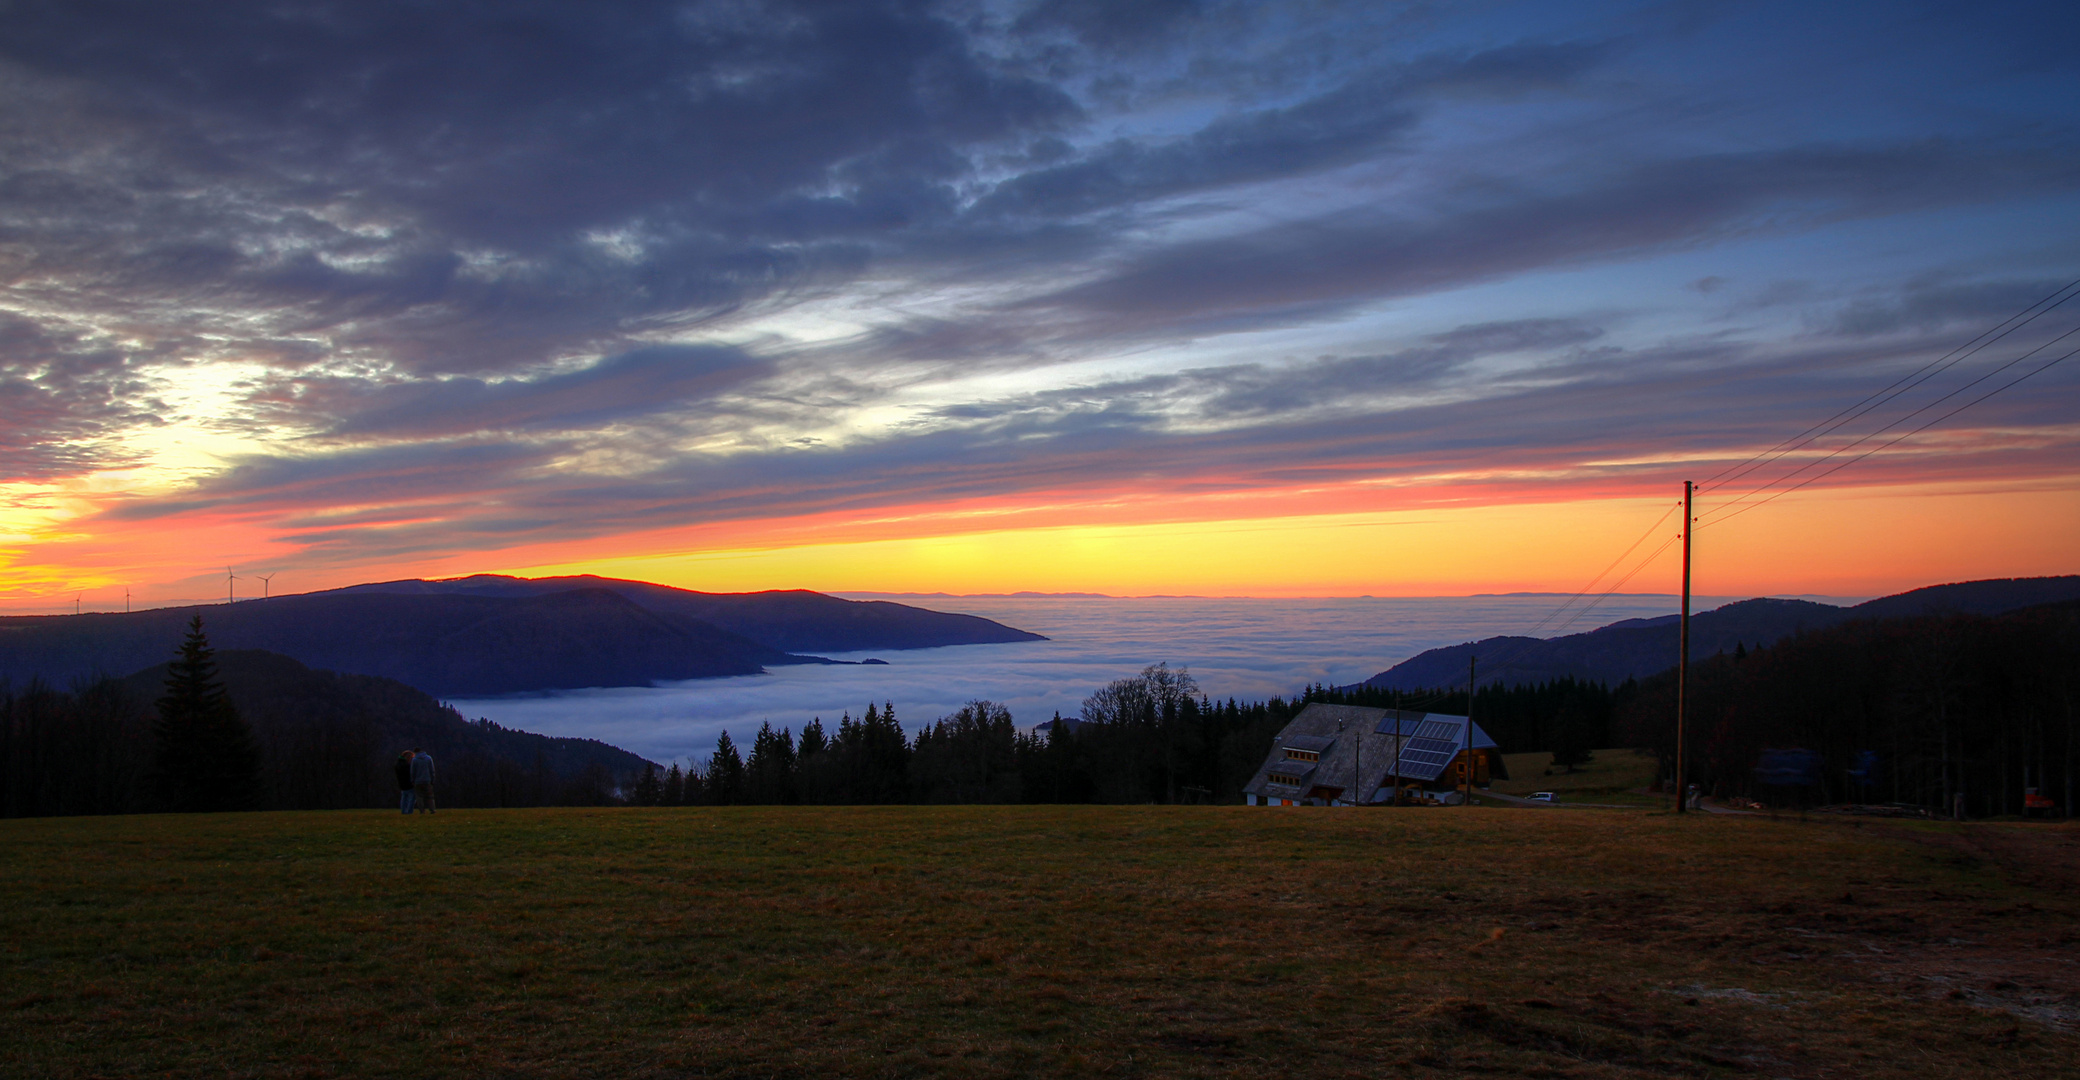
[0,574,1040,697]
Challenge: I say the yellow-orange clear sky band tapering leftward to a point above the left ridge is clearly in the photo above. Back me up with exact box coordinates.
[503,485,2080,597]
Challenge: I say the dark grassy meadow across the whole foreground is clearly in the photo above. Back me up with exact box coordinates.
[0,805,2080,1080]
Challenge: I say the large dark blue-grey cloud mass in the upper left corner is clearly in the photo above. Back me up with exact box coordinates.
[0,0,1077,372]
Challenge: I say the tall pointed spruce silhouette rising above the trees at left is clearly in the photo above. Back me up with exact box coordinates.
[152,616,260,814]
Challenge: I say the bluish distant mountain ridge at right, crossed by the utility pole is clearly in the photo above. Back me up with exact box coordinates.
[1362,574,2080,691]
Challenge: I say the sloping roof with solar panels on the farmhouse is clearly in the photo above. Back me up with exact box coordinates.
[1242,701,1496,799]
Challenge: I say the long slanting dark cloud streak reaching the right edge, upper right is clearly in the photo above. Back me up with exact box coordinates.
[1032,144,2080,325]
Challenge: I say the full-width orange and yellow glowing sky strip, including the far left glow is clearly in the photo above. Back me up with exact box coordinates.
[0,464,2080,614]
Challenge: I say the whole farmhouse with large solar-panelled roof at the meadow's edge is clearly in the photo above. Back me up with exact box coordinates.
[1242,701,1510,805]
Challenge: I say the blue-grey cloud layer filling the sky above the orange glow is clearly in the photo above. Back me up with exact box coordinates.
[0,0,2080,551]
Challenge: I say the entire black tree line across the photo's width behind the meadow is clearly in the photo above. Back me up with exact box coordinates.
[28,603,2046,816]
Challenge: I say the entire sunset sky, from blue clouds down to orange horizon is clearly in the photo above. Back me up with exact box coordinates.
[0,0,2080,614]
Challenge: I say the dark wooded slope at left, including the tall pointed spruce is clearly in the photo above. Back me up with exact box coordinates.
[0,618,641,818]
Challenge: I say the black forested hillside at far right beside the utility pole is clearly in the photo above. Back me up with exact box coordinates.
[1616,603,2080,816]
